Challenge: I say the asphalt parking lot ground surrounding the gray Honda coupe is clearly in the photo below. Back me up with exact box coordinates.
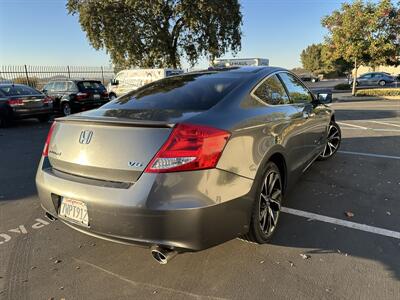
[0,101,400,299]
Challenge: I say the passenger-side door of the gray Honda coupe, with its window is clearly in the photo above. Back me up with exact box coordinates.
[279,72,329,167]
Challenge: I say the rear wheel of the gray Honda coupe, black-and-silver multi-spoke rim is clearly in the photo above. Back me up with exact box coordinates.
[244,162,283,244]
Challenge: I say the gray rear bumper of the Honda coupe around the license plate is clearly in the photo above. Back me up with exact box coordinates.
[36,158,253,251]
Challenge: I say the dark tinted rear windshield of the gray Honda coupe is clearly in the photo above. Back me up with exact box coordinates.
[103,73,243,110]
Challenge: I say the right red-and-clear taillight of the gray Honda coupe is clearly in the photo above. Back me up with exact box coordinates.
[145,124,230,173]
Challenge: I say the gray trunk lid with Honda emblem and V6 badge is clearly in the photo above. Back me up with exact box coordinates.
[48,116,173,182]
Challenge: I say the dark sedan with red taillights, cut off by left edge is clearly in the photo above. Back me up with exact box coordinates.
[0,83,53,127]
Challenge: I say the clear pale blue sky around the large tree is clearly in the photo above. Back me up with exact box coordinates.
[0,0,344,69]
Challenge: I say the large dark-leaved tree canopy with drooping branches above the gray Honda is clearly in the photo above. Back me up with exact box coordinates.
[67,0,242,68]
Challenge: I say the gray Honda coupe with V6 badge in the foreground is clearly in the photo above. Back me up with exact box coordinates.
[36,67,341,263]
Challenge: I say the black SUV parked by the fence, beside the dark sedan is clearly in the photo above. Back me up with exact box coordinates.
[43,80,110,116]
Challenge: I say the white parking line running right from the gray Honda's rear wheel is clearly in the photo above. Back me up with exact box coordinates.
[281,207,400,239]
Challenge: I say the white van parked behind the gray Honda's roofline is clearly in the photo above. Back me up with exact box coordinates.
[107,69,183,100]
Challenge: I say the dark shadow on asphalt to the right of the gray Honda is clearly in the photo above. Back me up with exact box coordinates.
[266,135,400,280]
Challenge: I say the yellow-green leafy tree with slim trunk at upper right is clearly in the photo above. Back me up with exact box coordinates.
[322,0,400,95]
